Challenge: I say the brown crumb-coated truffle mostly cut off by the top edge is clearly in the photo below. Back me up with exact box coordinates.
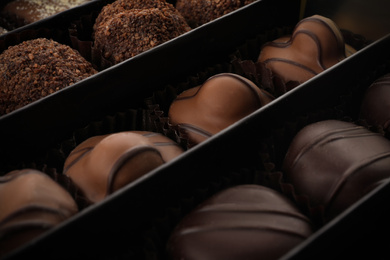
[175,0,255,28]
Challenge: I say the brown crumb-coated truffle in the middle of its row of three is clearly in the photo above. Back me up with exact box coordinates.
[94,1,191,64]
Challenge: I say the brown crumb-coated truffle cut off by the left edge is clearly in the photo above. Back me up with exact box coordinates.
[0,38,97,115]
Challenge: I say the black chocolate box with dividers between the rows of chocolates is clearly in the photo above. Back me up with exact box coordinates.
[0,0,390,259]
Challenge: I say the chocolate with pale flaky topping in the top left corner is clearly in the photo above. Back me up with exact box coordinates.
[1,0,91,27]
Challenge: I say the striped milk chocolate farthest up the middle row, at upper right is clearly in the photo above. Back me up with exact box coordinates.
[258,15,350,88]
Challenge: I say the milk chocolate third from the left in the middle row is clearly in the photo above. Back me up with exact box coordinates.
[168,73,274,145]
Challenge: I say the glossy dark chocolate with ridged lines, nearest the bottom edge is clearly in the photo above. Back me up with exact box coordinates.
[167,185,312,260]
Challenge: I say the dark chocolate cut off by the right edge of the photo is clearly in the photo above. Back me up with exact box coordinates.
[360,74,390,131]
